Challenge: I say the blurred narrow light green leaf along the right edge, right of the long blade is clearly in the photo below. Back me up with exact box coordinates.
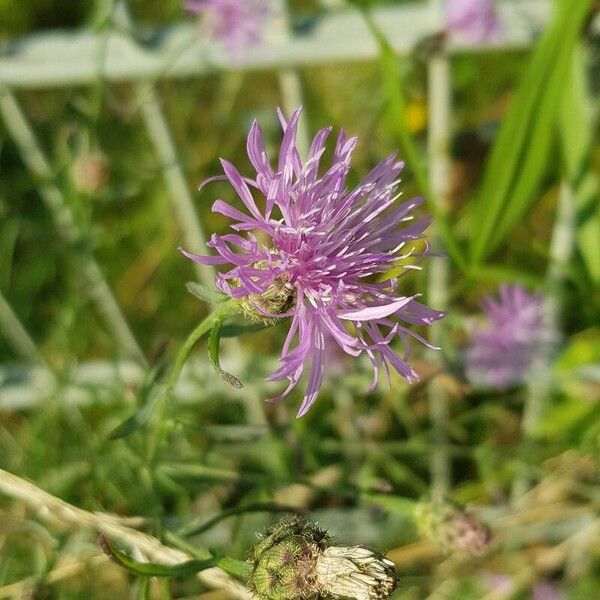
[560,47,600,285]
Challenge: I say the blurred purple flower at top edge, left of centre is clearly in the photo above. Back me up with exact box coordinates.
[185,0,269,58]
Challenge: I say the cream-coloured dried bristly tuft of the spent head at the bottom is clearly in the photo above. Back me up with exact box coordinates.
[316,546,396,600]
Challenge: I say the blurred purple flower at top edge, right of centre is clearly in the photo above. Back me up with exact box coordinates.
[446,0,502,44]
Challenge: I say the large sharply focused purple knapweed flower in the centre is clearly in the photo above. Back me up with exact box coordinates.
[184,110,443,416]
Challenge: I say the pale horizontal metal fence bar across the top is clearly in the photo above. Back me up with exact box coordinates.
[0,0,551,88]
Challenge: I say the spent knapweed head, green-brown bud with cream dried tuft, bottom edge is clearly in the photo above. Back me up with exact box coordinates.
[249,517,396,600]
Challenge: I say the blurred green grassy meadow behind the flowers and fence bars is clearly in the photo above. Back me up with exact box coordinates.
[0,0,600,600]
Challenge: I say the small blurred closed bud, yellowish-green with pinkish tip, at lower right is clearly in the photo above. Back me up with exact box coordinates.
[415,500,491,555]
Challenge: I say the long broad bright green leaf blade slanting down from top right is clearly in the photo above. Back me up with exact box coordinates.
[470,0,593,265]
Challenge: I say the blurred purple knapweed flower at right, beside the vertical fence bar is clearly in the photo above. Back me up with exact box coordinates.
[465,285,556,390]
